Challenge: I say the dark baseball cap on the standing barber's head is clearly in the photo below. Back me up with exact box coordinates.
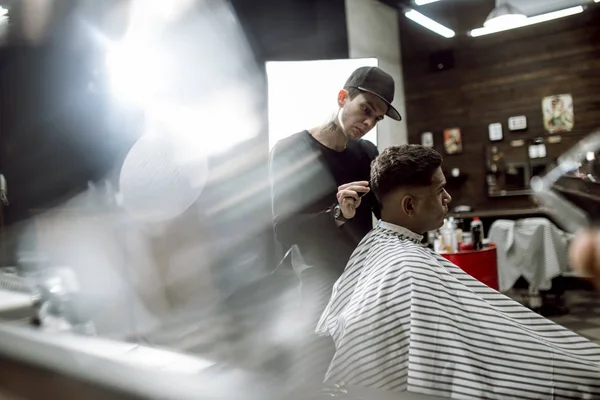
[344,67,402,121]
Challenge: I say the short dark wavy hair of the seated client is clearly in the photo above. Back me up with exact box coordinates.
[371,144,442,202]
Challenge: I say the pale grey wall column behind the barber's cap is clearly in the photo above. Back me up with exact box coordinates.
[346,0,408,150]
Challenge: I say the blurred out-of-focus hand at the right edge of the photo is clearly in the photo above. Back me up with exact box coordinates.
[569,230,600,289]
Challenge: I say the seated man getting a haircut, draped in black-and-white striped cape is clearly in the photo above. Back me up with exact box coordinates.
[317,145,600,399]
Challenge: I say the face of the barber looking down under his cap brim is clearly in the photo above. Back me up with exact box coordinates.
[338,90,388,140]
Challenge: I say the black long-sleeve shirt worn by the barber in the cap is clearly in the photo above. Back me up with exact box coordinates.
[269,131,380,274]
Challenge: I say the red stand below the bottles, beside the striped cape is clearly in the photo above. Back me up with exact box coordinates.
[441,244,499,290]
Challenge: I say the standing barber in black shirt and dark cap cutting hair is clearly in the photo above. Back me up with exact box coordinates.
[269,67,401,284]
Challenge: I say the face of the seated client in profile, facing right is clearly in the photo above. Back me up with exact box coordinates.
[414,168,452,233]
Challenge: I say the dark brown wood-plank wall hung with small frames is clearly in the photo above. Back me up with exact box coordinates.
[400,0,600,210]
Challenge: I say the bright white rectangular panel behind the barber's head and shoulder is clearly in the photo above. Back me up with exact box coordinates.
[266,58,378,149]
